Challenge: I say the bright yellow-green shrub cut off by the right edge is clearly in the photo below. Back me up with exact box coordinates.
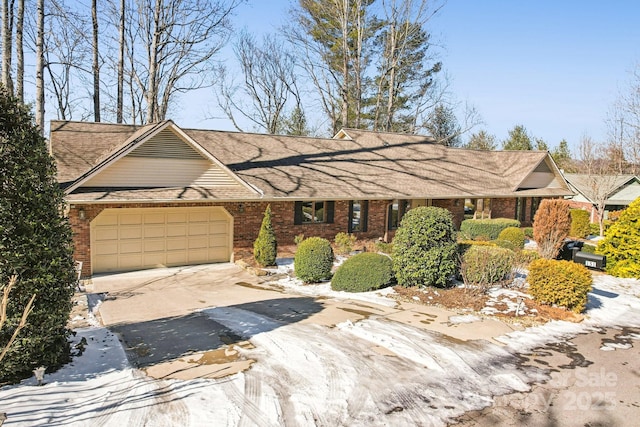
[596,198,640,279]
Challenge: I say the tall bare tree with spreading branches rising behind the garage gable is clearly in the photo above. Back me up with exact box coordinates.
[127,0,241,122]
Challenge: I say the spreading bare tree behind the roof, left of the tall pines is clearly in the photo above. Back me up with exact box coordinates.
[217,31,302,134]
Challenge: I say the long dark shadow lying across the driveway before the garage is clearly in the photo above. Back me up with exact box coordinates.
[111,297,323,368]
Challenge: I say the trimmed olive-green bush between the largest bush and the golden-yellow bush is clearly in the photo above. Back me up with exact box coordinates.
[460,245,515,286]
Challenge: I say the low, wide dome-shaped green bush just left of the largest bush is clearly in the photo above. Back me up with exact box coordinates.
[331,252,393,292]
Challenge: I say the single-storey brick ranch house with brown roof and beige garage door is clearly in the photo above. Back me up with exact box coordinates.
[50,120,572,276]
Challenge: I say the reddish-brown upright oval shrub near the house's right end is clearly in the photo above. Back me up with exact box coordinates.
[533,199,571,259]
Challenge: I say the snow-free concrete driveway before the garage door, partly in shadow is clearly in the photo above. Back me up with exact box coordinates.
[87,263,512,379]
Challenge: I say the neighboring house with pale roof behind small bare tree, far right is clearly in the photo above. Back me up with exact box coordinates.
[564,173,640,223]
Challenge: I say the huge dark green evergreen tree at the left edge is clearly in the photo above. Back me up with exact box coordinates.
[0,87,76,384]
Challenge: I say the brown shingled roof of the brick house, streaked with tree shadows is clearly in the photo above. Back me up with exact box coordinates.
[51,122,572,200]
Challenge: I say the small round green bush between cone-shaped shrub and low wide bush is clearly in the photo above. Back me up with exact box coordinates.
[293,237,333,283]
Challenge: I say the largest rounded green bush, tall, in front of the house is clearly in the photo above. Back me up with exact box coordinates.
[393,206,458,287]
